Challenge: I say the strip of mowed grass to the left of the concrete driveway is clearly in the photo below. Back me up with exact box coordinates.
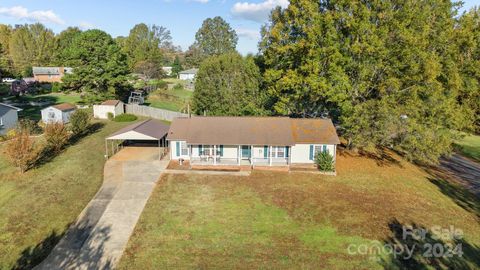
[0,119,130,269]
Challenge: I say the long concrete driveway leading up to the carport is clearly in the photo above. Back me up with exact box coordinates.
[36,147,168,269]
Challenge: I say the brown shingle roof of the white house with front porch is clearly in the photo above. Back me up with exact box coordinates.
[167,117,339,145]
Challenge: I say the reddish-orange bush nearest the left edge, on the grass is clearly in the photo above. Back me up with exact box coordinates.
[5,130,41,173]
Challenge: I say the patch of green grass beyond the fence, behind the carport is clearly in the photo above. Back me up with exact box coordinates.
[146,89,193,111]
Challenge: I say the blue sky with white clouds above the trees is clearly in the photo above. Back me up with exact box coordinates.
[0,0,480,54]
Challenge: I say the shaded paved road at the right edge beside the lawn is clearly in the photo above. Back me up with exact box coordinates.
[439,154,480,197]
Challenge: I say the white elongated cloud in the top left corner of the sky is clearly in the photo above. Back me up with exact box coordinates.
[0,6,65,25]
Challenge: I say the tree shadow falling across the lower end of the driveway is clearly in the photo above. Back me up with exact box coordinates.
[13,208,113,270]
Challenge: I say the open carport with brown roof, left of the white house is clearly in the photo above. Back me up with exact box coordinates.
[105,119,170,159]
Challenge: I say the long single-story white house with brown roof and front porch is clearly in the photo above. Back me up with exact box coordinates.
[167,117,340,166]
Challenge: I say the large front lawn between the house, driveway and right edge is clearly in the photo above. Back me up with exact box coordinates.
[119,152,480,269]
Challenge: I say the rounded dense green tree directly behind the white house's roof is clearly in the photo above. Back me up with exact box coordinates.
[192,53,264,115]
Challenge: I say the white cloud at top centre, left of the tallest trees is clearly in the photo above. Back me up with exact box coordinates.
[231,0,289,23]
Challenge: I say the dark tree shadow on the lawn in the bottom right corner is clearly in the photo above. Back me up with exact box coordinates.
[380,219,480,269]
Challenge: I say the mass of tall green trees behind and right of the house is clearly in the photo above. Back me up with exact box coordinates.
[192,0,480,163]
